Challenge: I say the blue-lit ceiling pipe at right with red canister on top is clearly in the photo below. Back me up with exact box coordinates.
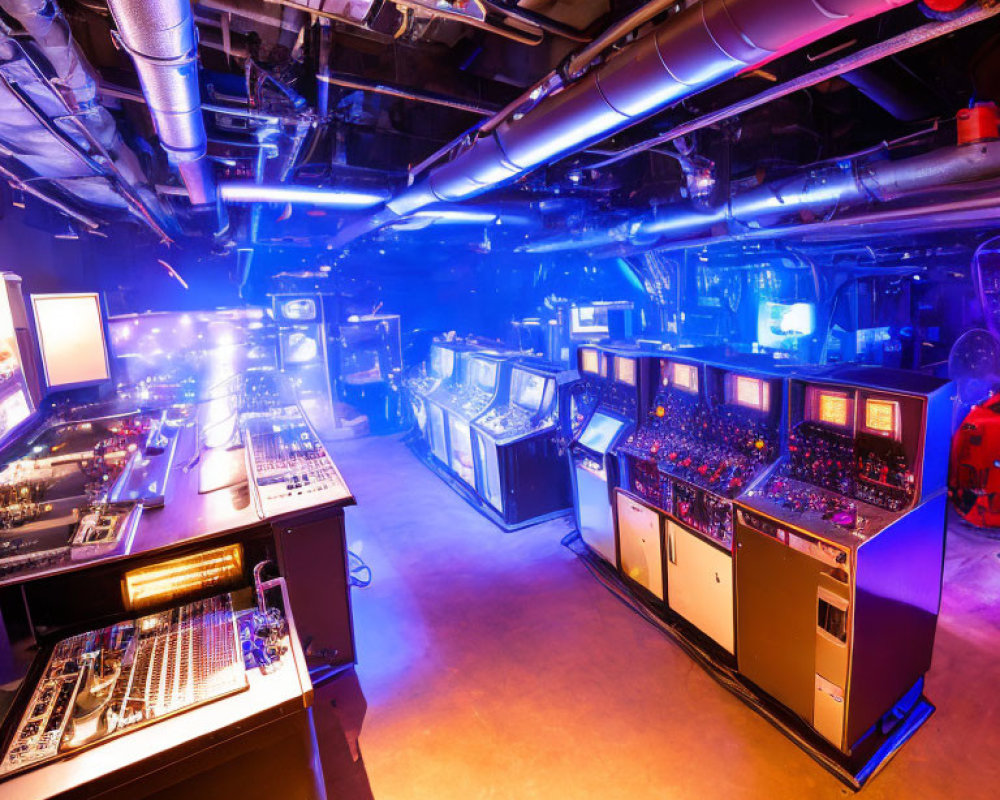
[518,141,1000,253]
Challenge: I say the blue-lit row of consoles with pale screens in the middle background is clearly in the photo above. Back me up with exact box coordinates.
[404,340,572,530]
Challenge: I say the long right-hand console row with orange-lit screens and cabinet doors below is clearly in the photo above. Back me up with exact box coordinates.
[570,346,952,786]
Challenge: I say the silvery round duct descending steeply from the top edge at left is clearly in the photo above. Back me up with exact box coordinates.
[108,0,216,205]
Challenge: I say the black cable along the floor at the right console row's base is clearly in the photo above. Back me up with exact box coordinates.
[560,531,860,790]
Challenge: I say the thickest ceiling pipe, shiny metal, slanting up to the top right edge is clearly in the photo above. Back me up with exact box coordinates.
[333,0,910,246]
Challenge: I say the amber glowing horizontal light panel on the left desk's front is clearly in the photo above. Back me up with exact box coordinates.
[122,544,243,611]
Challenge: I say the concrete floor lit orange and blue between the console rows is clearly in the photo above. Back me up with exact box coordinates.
[335,438,1000,800]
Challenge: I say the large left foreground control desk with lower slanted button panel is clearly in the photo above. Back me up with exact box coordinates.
[0,369,364,798]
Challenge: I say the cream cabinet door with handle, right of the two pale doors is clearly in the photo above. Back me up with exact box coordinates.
[667,520,735,653]
